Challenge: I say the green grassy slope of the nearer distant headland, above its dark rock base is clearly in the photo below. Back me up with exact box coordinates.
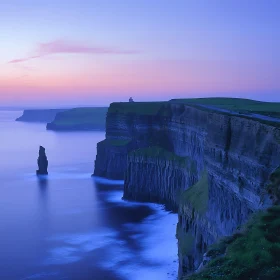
[49,107,108,128]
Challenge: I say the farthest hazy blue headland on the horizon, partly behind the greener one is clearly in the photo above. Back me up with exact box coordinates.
[16,109,65,123]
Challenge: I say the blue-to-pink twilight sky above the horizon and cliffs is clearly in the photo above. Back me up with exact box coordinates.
[0,0,280,107]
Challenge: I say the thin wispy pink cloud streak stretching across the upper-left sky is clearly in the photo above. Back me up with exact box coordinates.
[8,40,137,63]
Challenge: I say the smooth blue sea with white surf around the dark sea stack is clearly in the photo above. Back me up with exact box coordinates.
[0,111,177,280]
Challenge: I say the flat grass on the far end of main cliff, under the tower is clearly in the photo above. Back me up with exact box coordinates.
[108,102,166,115]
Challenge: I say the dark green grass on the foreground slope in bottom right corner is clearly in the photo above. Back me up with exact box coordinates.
[183,206,280,280]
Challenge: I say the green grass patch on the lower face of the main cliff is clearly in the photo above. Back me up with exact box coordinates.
[180,171,208,214]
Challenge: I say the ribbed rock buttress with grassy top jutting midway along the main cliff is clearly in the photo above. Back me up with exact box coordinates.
[124,146,197,209]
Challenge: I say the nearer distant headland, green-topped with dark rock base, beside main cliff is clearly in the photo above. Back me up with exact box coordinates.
[47,107,108,131]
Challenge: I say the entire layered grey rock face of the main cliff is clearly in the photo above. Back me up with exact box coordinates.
[95,103,280,274]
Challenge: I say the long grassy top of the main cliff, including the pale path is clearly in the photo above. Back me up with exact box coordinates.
[108,97,280,128]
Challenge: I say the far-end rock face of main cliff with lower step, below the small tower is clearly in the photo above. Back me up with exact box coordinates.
[94,108,165,179]
